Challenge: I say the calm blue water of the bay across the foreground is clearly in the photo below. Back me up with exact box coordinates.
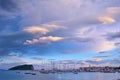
[0,71,120,80]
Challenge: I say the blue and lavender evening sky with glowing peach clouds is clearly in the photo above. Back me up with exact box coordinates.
[0,0,120,69]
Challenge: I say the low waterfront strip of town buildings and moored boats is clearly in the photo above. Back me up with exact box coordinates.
[40,66,120,74]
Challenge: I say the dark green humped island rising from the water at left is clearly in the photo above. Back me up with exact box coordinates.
[8,64,34,70]
